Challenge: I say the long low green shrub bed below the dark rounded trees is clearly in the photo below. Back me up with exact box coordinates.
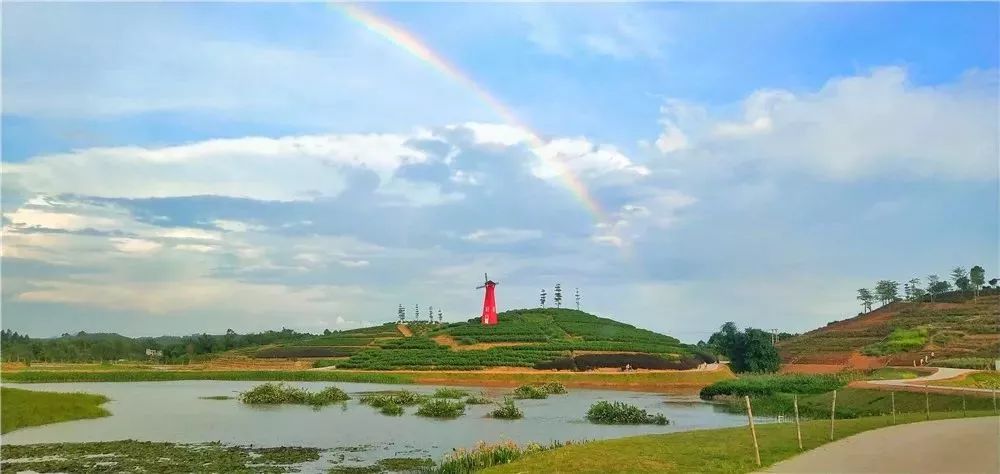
[699,374,846,400]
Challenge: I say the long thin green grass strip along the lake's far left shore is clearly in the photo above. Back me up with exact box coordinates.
[2,370,414,384]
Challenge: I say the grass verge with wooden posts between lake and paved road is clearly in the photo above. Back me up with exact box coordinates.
[482,410,993,474]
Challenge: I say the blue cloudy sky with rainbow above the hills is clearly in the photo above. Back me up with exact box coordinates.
[0,2,1000,342]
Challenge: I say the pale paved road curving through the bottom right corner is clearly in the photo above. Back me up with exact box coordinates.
[764,417,1000,474]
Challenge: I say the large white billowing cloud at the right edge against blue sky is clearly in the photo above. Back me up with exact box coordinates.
[657,67,1000,180]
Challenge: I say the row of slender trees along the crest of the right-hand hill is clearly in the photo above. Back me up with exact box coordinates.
[857,265,1000,312]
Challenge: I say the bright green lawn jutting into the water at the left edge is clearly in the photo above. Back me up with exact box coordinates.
[0,387,111,433]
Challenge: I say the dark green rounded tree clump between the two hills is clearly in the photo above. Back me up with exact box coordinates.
[708,321,781,373]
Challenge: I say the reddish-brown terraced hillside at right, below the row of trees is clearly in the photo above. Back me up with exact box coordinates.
[778,292,1000,366]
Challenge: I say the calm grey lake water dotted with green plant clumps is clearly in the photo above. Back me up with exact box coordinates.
[3,380,766,468]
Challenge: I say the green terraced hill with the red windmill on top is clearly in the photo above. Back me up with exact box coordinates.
[255,308,710,370]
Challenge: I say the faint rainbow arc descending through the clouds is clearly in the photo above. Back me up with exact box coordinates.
[333,3,607,223]
